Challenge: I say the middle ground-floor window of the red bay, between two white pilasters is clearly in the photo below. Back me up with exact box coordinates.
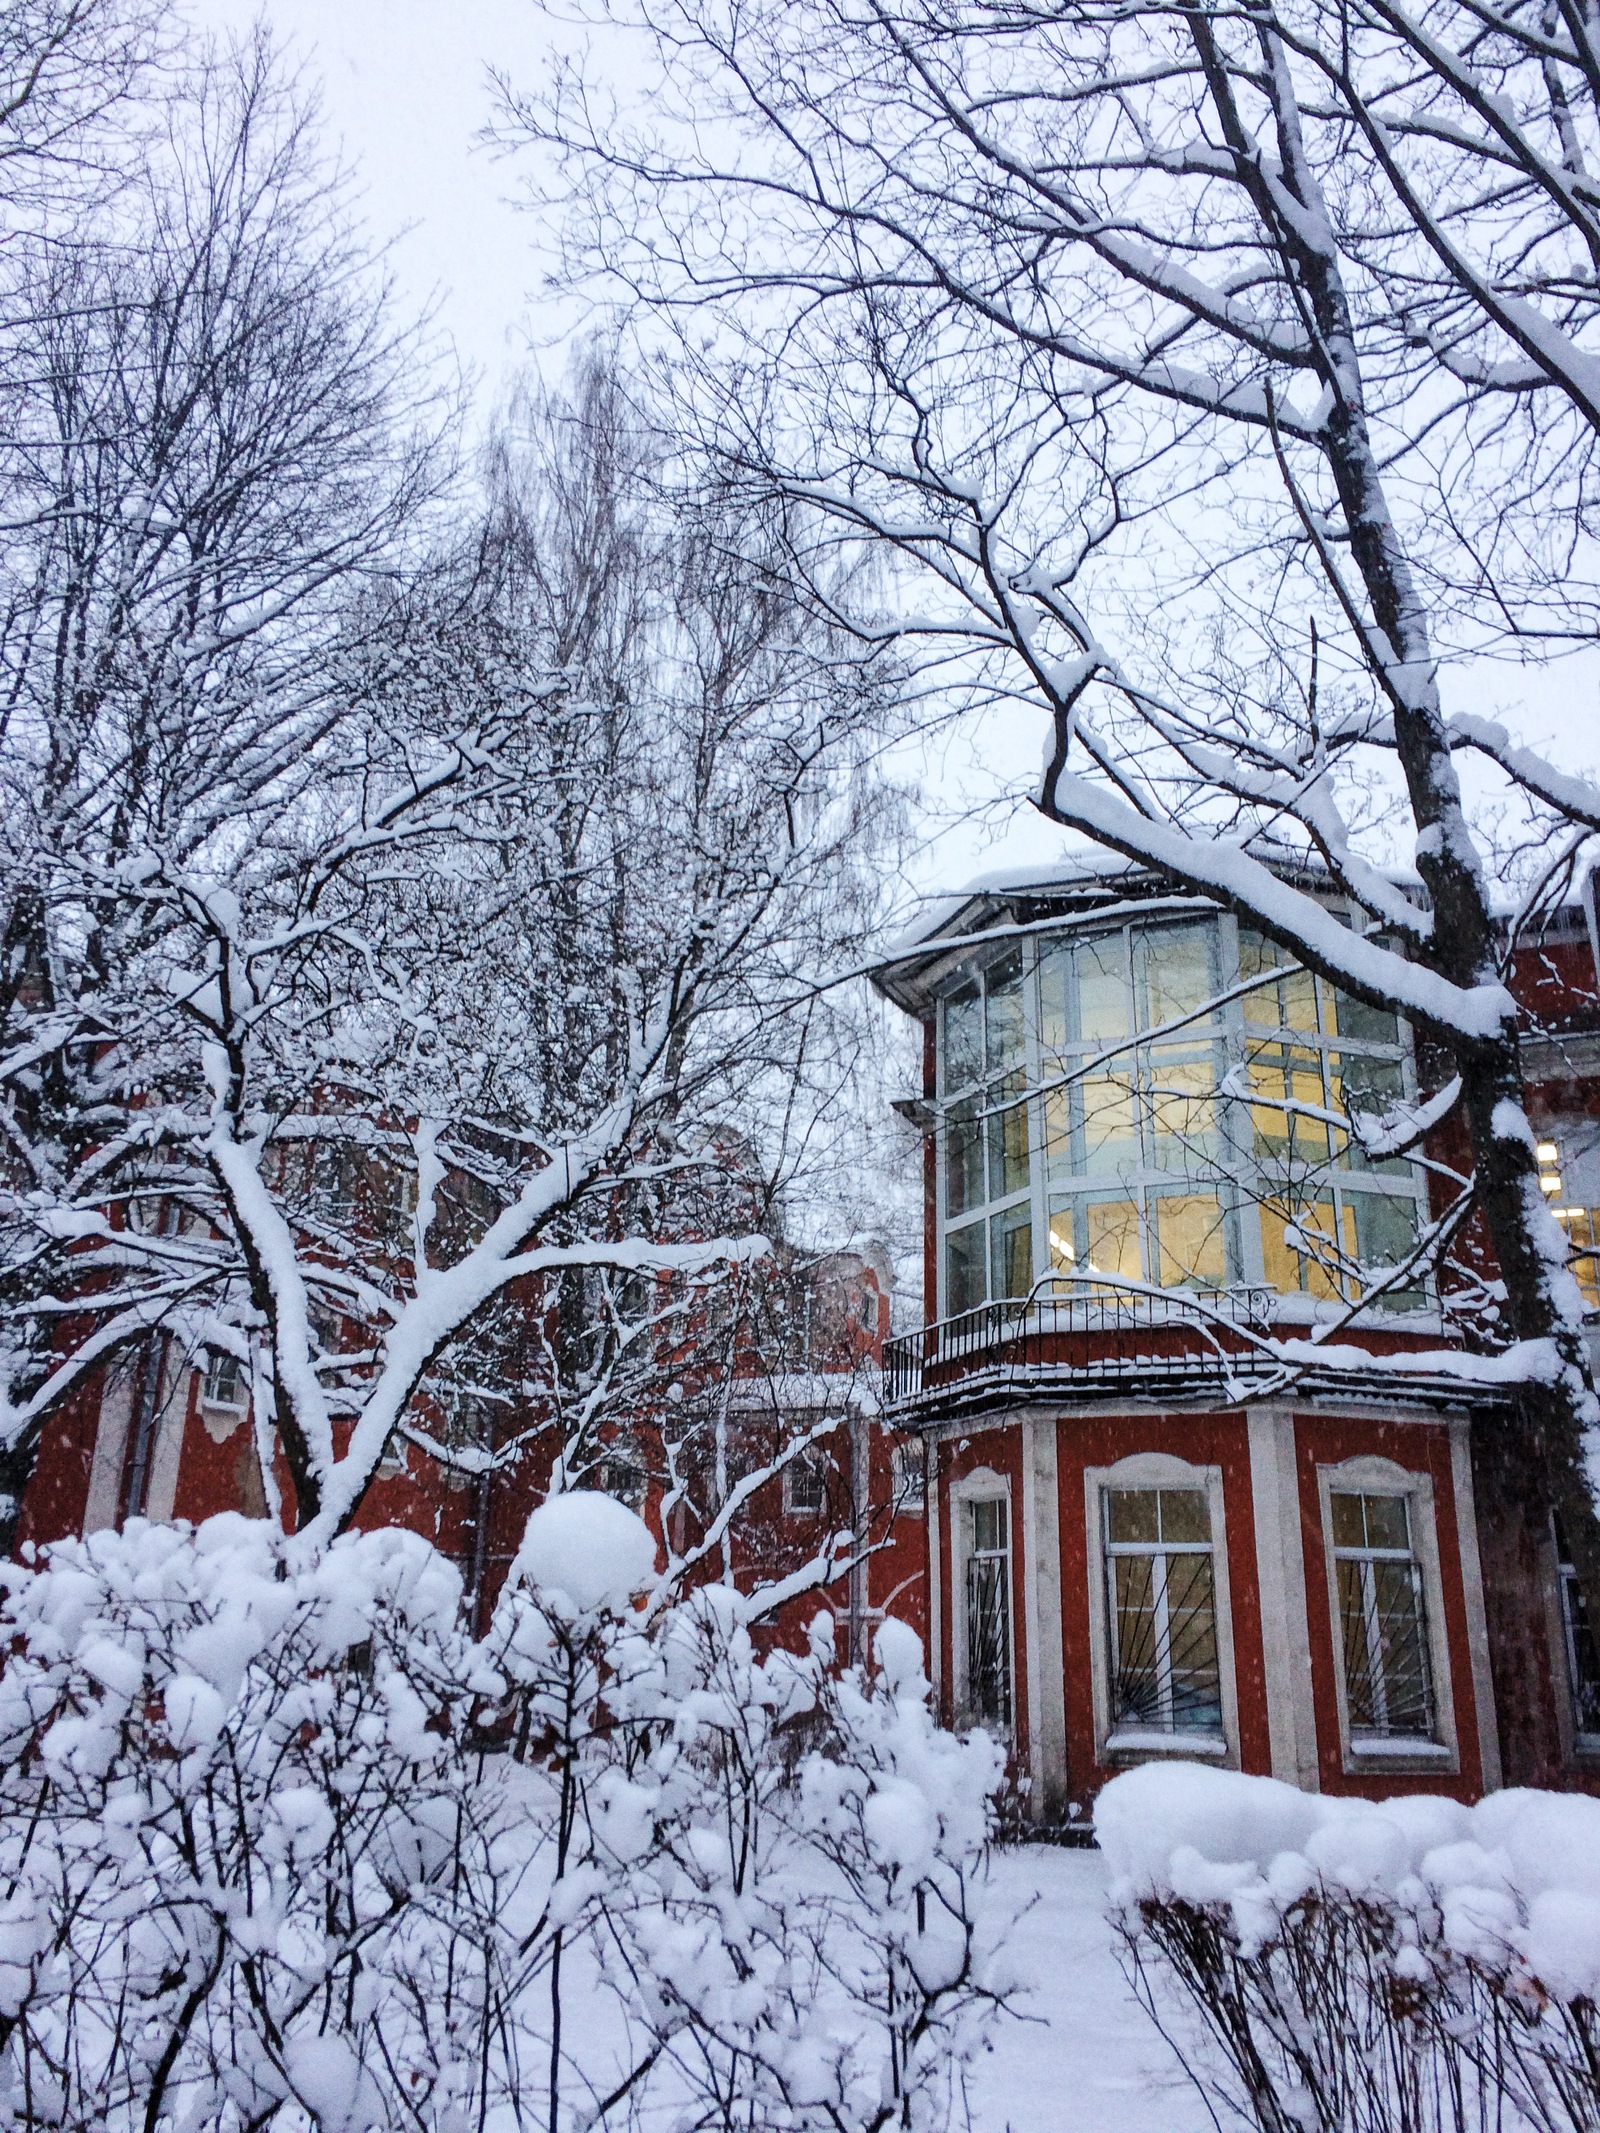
[1105,1489,1222,1736]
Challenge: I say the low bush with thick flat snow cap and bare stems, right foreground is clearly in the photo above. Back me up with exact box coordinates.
[1094,1764,1600,2133]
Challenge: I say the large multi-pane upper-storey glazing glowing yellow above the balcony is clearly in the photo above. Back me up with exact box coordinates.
[939,917,1433,1316]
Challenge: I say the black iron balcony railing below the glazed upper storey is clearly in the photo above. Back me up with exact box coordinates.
[883,1288,1274,1406]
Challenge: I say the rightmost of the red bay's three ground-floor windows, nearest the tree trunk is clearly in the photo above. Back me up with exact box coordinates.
[1329,1491,1434,1747]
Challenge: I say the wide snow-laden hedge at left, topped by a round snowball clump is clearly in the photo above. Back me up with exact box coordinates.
[0,1493,1019,2133]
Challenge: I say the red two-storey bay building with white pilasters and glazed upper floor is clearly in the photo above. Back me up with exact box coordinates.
[877,866,1600,1822]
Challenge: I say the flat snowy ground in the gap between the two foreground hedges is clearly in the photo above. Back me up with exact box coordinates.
[971,1845,1212,2133]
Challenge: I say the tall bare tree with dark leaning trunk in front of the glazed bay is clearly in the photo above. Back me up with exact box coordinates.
[501,0,1600,1629]
